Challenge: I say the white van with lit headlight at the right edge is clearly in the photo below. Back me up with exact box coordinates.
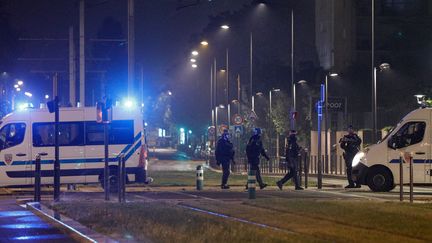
[352,108,432,191]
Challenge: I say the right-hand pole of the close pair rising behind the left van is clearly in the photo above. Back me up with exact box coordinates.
[79,0,85,107]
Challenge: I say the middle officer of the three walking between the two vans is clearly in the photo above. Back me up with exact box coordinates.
[246,128,270,189]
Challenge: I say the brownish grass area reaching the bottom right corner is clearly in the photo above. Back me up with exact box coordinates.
[183,198,432,242]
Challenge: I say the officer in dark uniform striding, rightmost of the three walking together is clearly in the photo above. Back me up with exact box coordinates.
[276,130,303,190]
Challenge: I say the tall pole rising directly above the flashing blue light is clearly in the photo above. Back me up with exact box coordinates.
[128,0,135,97]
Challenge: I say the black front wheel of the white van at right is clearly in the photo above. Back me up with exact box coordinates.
[367,167,394,192]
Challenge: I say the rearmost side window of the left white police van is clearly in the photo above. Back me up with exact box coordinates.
[85,120,134,145]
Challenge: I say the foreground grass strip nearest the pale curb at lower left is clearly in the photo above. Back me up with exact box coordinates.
[53,201,317,242]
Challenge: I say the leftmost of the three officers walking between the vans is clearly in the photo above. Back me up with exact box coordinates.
[215,130,234,189]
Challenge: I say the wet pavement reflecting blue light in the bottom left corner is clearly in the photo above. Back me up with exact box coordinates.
[0,198,76,243]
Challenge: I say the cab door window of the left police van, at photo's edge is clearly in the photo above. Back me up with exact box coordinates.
[0,123,26,150]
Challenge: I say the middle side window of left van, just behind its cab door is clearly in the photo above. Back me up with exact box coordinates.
[33,122,84,147]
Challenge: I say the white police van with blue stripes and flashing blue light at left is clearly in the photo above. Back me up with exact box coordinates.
[0,107,147,186]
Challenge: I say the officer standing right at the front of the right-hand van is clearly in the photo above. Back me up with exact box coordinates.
[339,126,362,188]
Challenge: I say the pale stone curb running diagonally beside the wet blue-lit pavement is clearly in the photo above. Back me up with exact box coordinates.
[26,202,118,243]
